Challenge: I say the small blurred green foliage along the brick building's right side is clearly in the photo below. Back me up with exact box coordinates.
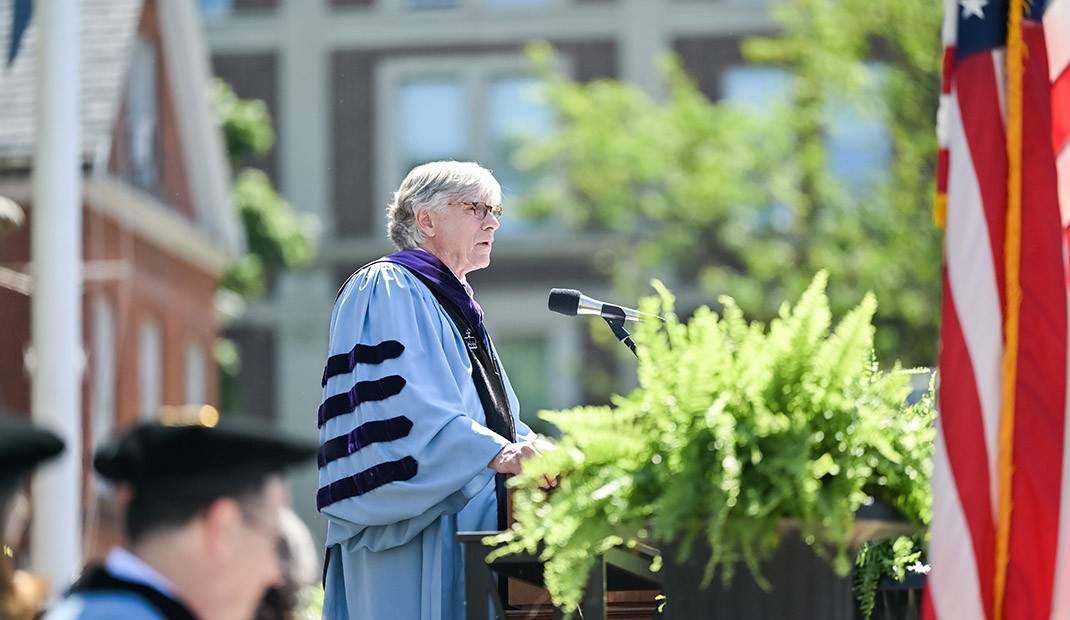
[211,78,317,298]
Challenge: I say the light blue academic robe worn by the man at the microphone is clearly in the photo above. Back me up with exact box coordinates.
[319,262,534,620]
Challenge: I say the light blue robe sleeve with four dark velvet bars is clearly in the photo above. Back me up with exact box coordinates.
[318,263,515,549]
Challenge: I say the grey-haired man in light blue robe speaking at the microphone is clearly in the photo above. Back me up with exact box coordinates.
[317,162,537,620]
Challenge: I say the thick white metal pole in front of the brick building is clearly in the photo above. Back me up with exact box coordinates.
[30,0,82,596]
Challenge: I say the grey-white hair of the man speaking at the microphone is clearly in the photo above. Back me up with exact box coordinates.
[386,161,502,249]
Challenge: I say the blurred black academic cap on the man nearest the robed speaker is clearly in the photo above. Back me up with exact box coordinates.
[93,419,317,490]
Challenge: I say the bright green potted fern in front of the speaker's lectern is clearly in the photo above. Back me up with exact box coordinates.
[493,272,930,611]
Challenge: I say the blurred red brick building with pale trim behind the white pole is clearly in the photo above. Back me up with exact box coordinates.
[0,0,244,552]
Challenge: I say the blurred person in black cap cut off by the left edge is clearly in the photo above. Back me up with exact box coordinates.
[0,414,64,620]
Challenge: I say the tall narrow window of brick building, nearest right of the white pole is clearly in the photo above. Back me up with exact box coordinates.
[90,294,117,448]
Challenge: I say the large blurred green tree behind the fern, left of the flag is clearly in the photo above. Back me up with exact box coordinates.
[518,0,942,365]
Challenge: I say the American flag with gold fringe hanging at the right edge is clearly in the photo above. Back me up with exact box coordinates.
[923,0,1070,620]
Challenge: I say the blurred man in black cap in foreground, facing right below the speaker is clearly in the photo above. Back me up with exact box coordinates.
[45,410,316,620]
